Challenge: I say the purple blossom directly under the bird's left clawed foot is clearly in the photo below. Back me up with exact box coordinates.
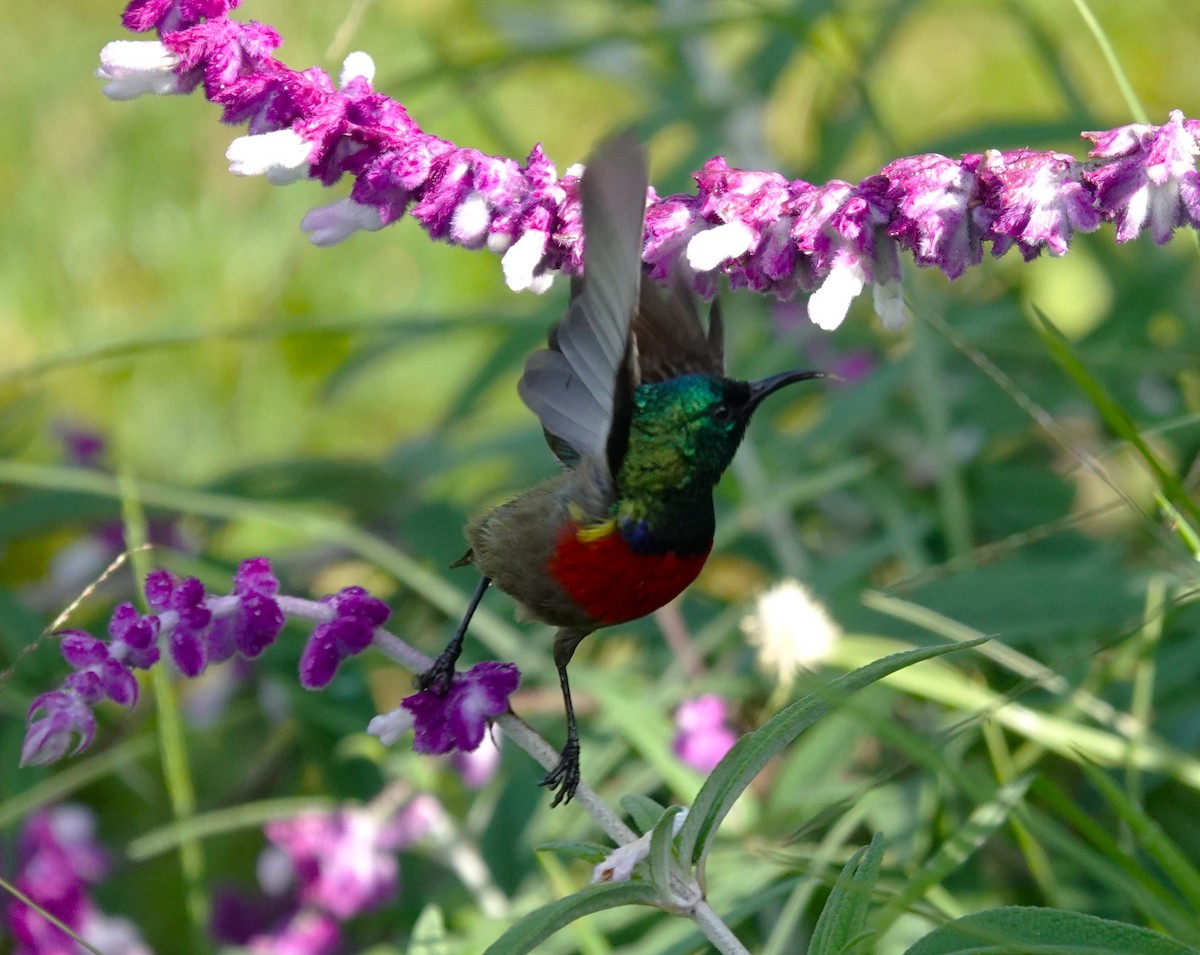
[401,661,521,753]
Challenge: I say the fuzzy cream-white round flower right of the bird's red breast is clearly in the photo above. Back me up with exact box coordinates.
[742,579,841,690]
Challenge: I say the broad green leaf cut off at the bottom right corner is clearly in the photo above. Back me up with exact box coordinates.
[905,906,1198,955]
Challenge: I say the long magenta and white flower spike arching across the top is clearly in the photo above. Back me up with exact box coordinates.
[98,0,1200,329]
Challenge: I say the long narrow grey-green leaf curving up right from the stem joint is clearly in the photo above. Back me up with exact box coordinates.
[679,637,988,864]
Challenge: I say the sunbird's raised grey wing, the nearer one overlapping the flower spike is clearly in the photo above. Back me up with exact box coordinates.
[517,133,648,475]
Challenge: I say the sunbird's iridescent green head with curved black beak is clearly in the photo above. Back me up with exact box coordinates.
[618,372,822,494]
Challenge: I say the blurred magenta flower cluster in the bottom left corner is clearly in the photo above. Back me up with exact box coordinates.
[5,805,150,955]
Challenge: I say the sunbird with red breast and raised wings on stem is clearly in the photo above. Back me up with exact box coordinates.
[416,132,823,806]
